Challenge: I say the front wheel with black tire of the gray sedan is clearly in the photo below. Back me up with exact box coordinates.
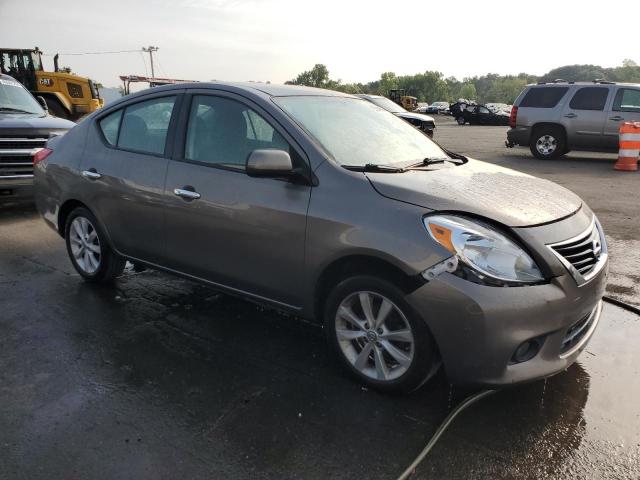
[324,275,439,393]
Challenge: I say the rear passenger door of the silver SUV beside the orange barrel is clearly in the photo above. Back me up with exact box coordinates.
[562,86,611,148]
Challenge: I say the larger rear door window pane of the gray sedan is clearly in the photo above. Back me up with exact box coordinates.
[117,97,176,154]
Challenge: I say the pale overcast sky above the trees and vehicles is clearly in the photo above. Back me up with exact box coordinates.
[0,0,640,86]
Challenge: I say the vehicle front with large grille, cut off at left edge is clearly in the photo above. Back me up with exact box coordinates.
[0,74,75,200]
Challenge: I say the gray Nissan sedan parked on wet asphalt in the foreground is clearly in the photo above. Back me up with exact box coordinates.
[35,83,607,391]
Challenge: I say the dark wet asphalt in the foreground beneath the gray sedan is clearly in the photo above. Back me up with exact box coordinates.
[0,122,640,480]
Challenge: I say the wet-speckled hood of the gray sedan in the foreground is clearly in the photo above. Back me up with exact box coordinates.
[366,159,582,227]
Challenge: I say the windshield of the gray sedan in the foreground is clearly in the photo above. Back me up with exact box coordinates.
[274,96,448,166]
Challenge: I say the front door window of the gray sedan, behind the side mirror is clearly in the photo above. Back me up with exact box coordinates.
[185,95,290,169]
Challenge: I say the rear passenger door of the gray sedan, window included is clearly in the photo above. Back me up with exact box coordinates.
[81,92,181,263]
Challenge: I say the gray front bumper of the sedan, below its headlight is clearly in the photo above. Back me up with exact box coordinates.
[407,251,608,386]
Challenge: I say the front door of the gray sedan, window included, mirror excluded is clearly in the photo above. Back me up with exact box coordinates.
[160,93,311,307]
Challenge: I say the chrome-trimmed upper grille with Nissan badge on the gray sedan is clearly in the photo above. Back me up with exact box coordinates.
[549,218,607,284]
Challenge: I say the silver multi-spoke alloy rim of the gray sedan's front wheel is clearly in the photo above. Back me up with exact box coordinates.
[335,291,415,382]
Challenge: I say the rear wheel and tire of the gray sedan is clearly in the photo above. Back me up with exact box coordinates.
[64,207,126,283]
